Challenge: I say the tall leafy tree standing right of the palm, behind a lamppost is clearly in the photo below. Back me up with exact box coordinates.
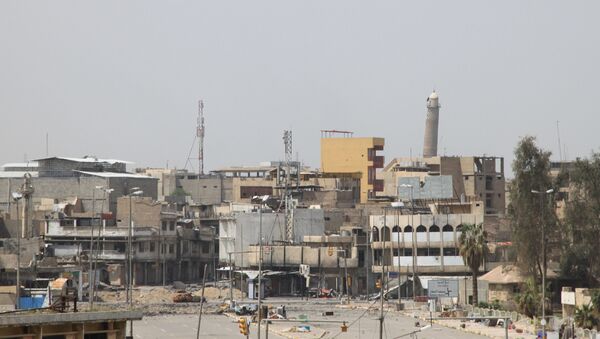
[508,136,558,282]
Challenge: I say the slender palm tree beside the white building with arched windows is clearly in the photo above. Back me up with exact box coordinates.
[459,224,487,305]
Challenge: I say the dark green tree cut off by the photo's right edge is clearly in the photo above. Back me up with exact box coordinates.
[564,153,600,284]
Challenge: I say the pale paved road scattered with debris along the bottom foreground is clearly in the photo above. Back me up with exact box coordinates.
[134,299,485,339]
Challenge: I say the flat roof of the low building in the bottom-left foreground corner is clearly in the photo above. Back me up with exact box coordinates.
[0,311,143,326]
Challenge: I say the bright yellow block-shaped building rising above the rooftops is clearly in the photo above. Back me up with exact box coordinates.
[321,131,385,203]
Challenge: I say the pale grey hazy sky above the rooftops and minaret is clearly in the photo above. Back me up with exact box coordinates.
[0,0,600,178]
